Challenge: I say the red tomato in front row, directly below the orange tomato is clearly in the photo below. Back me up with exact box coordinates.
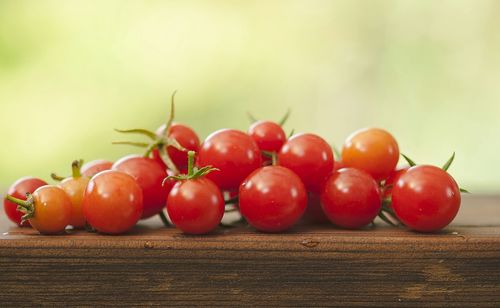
[321,168,382,229]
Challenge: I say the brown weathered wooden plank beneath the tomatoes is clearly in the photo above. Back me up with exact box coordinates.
[0,196,500,307]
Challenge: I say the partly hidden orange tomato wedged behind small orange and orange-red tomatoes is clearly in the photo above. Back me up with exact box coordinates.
[60,176,90,228]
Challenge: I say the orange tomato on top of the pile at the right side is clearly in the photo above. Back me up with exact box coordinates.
[342,128,399,181]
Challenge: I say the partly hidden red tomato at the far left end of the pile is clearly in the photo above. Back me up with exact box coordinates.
[3,177,47,227]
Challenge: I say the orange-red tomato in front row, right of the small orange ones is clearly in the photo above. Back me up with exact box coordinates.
[82,170,143,234]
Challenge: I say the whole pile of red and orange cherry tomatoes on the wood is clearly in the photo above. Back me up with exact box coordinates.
[4,97,465,234]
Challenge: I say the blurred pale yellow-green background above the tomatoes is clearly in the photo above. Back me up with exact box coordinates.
[0,0,500,193]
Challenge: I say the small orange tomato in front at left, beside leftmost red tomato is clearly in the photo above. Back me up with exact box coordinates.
[28,185,71,234]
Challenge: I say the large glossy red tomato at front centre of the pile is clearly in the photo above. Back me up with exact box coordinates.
[239,166,307,232]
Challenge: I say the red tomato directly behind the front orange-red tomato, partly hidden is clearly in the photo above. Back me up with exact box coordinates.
[112,155,173,219]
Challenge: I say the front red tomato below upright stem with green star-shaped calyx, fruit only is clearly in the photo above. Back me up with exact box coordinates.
[167,178,224,234]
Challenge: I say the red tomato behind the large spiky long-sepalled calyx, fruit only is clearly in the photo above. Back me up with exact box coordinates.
[153,123,200,170]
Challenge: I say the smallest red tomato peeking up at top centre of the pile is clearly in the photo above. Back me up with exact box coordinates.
[248,121,286,152]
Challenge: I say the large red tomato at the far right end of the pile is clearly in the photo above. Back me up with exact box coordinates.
[392,165,461,232]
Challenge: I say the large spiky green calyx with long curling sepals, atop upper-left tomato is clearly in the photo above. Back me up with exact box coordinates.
[113,91,187,173]
